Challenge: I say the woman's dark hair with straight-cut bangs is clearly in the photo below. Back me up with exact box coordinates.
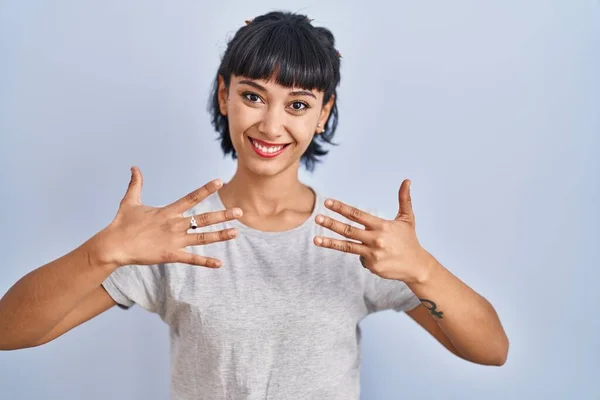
[209,11,340,172]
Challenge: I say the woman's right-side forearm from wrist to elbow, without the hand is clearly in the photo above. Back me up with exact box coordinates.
[408,255,508,365]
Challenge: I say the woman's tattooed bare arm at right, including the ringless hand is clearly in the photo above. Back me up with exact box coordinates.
[314,179,508,365]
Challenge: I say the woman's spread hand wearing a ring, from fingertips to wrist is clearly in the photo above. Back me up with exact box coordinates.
[92,167,242,268]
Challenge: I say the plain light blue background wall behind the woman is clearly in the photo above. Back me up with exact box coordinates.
[0,0,600,400]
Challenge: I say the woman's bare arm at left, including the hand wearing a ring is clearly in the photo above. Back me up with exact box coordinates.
[0,167,242,350]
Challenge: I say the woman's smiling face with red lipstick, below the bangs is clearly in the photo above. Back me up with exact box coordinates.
[219,76,334,176]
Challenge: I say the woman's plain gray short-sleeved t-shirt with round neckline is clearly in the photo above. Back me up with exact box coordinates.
[103,193,420,400]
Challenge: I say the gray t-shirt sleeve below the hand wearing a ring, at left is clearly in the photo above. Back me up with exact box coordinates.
[102,265,166,315]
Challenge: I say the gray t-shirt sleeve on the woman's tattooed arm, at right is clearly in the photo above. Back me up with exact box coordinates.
[364,270,421,314]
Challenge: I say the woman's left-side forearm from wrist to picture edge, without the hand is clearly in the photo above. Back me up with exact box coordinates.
[0,233,117,349]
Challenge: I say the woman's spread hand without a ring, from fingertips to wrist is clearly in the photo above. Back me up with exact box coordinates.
[314,179,432,283]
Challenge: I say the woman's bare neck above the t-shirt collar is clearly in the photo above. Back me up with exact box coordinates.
[219,160,311,216]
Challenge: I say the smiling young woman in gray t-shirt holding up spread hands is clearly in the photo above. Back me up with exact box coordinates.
[0,12,508,400]
